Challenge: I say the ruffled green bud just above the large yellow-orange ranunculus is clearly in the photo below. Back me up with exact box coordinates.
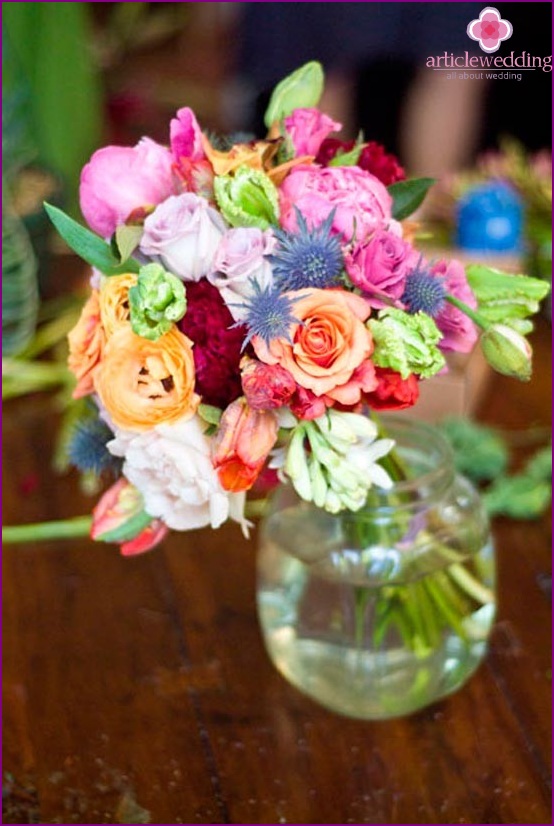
[129,264,187,341]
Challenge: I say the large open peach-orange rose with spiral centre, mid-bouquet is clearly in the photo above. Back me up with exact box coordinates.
[252,288,376,404]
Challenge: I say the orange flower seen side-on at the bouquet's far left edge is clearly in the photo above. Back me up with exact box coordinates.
[67,290,106,399]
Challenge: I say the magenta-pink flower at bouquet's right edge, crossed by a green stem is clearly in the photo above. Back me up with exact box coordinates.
[431,260,477,353]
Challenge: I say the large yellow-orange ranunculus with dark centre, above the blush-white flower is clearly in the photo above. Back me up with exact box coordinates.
[94,324,200,431]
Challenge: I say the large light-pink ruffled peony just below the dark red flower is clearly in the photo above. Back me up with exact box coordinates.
[280,164,392,243]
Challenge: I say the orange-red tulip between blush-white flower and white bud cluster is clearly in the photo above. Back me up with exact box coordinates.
[213,398,279,493]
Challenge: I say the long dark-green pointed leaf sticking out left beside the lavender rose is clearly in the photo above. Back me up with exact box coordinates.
[44,202,140,275]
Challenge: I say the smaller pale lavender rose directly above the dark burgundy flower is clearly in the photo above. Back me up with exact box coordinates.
[208,227,276,321]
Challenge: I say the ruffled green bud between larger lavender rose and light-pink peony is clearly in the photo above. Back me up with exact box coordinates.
[214,166,279,230]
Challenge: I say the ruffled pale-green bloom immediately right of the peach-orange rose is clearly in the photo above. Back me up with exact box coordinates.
[368,307,445,379]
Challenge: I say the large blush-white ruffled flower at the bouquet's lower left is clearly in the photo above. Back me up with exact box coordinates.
[108,416,248,532]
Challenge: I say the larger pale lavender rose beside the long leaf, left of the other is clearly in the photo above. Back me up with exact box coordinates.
[140,192,226,281]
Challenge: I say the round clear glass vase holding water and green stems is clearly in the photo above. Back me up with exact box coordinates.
[257,418,495,720]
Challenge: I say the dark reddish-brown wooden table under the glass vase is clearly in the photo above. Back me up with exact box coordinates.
[3,321,551,824]
